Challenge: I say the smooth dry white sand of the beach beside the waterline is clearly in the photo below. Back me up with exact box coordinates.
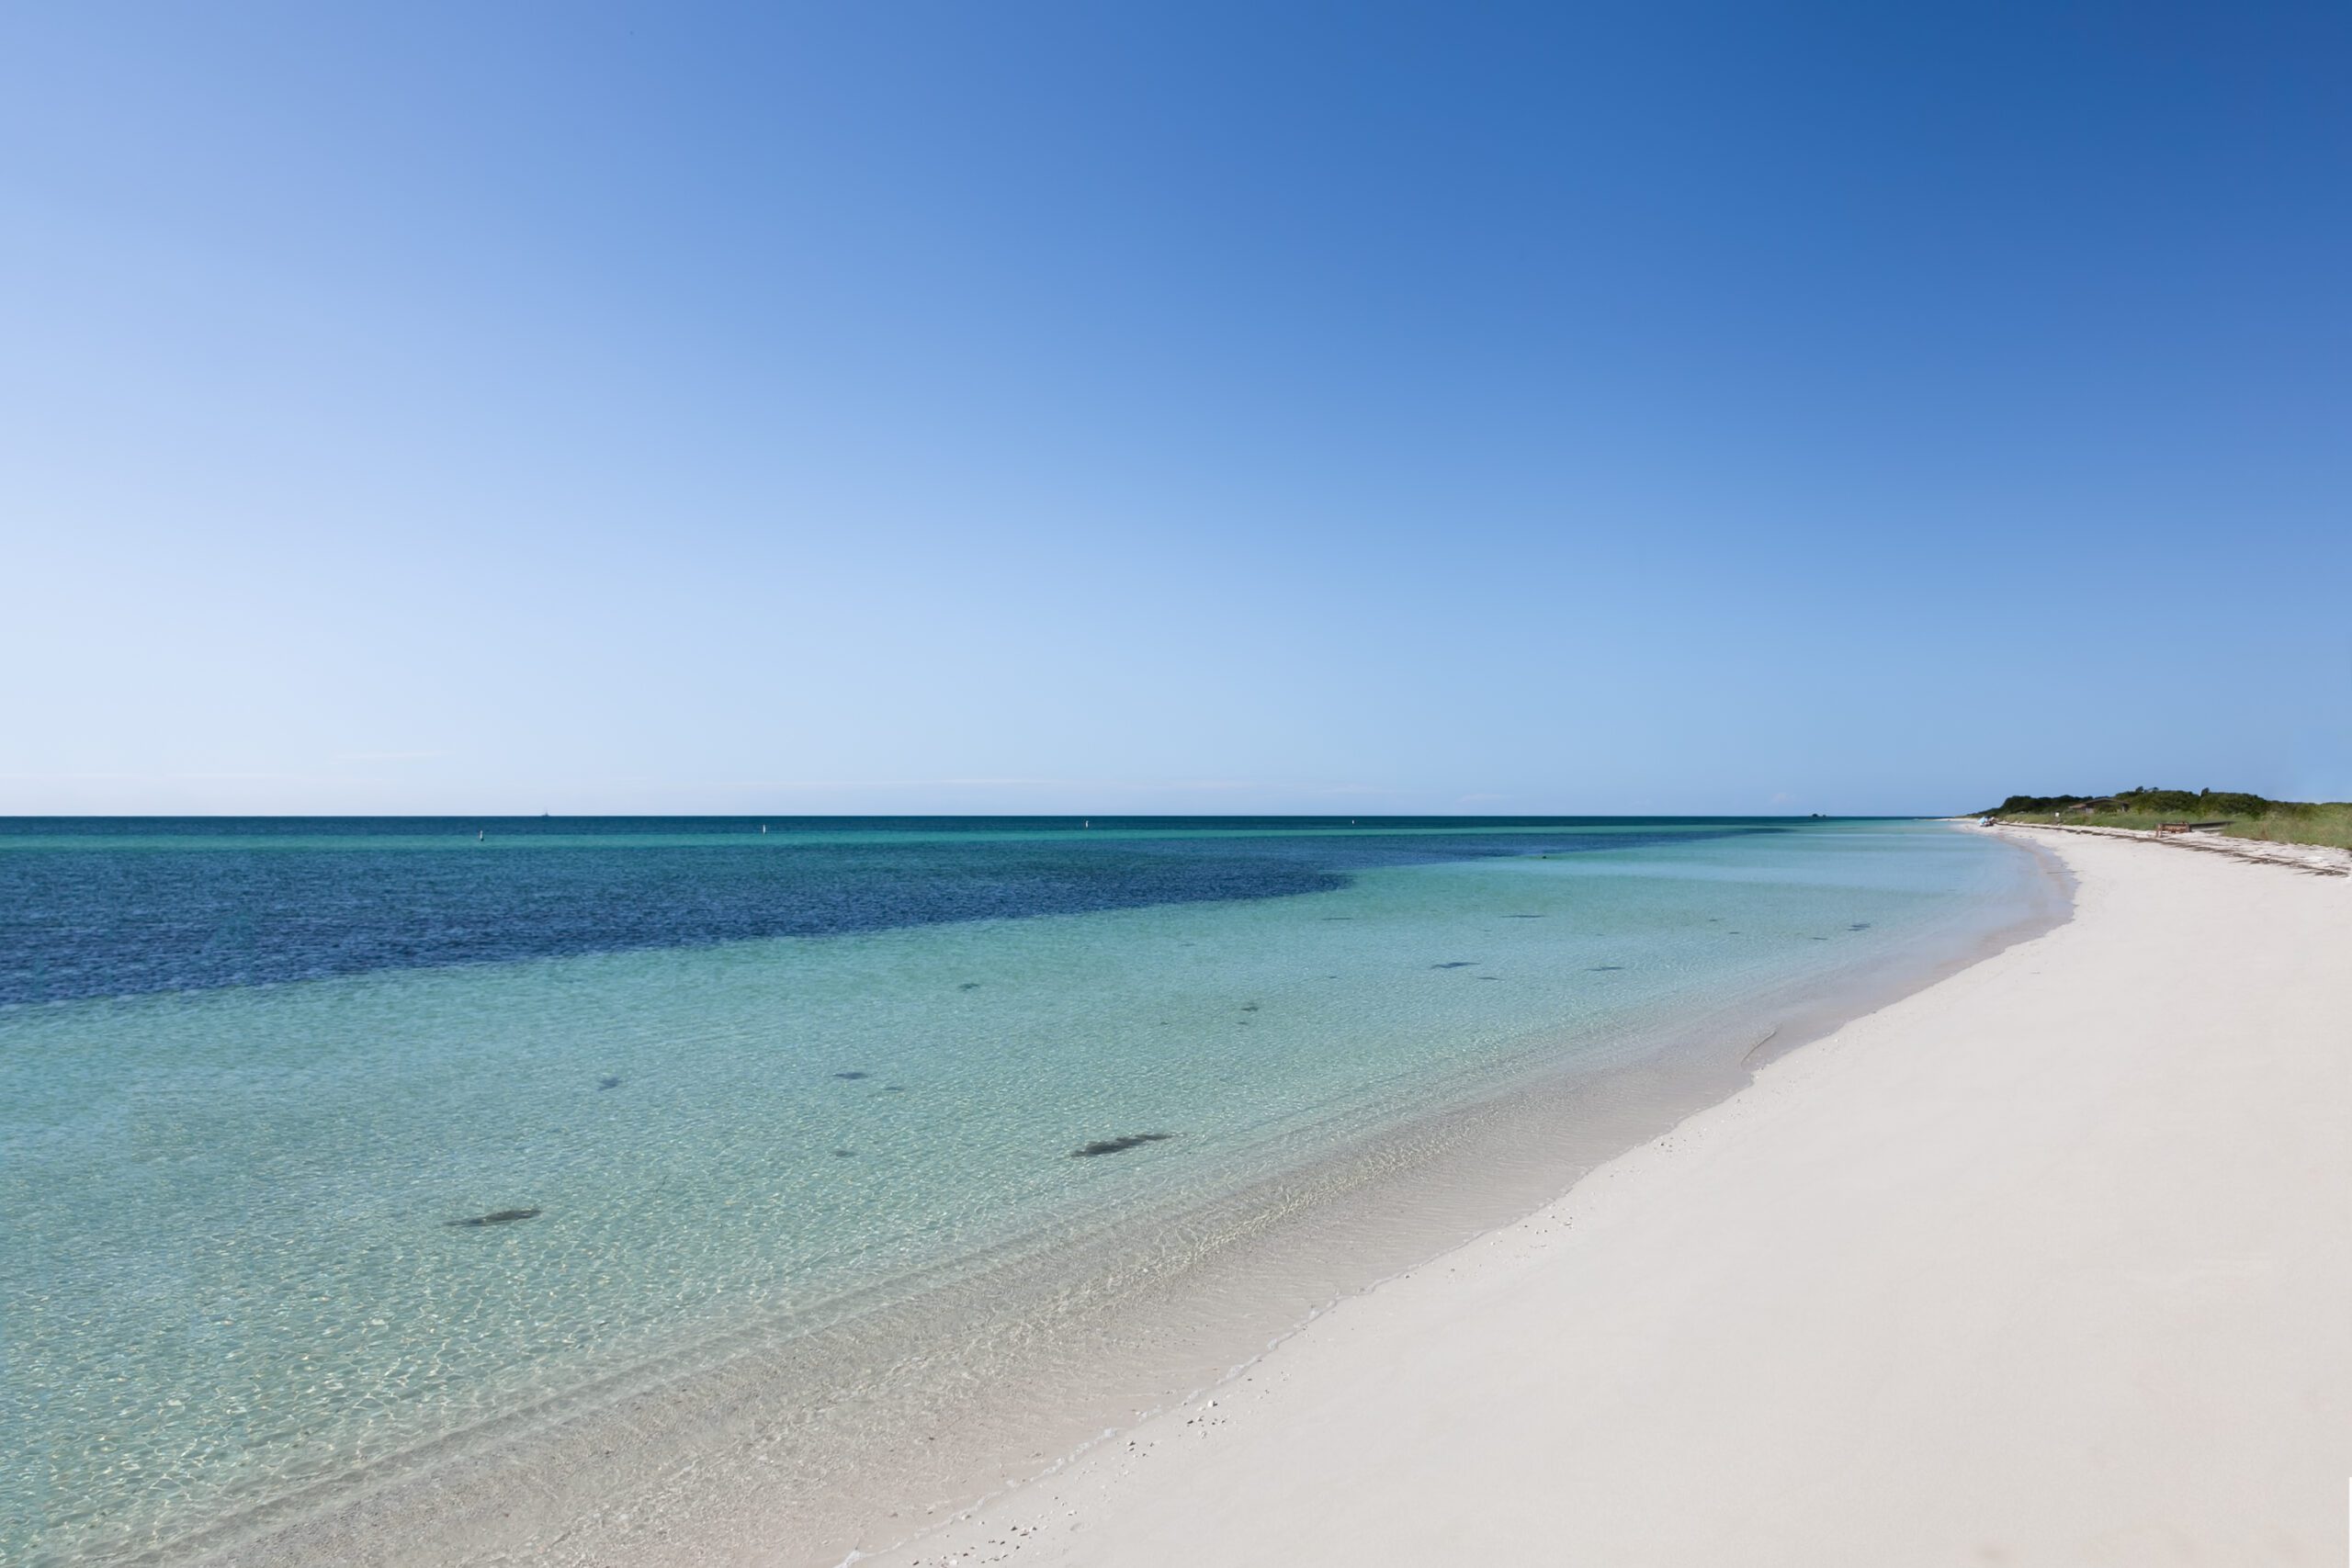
[879,835,2352,1568]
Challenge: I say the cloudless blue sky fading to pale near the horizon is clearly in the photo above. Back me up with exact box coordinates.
[0,0,2352,813]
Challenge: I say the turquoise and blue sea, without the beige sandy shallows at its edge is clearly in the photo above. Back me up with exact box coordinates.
[0,823,2023,1563]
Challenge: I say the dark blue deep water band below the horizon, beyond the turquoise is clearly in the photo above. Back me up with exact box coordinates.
[0,818,1788,1006]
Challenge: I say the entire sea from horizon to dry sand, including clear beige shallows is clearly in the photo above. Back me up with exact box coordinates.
[0,818,2049,1565]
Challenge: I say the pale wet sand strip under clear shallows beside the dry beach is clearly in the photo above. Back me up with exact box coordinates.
[178,829,2067,1568]
